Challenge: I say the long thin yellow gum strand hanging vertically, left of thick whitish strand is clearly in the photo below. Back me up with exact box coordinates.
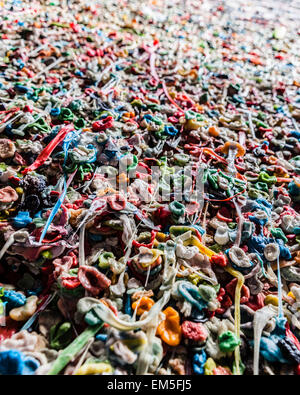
[224,267,245,376]
